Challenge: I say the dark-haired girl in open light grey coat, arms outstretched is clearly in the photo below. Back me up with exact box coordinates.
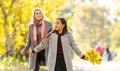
[30,18,86,71]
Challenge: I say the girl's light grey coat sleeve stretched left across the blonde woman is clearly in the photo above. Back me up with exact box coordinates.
[33,37,49,53]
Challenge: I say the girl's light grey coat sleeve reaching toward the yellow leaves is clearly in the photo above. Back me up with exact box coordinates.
[69,33,83,57]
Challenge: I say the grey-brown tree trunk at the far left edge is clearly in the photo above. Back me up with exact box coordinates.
[0,4,14,56]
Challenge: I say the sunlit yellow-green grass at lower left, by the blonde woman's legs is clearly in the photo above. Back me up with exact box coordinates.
[0,57,47,71]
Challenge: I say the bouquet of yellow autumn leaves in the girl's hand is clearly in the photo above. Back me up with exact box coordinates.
[85,48,101,64]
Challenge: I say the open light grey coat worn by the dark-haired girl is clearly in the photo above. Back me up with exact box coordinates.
[33,33,83,71]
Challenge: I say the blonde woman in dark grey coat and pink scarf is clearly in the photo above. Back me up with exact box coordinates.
[21,8,52,71]
